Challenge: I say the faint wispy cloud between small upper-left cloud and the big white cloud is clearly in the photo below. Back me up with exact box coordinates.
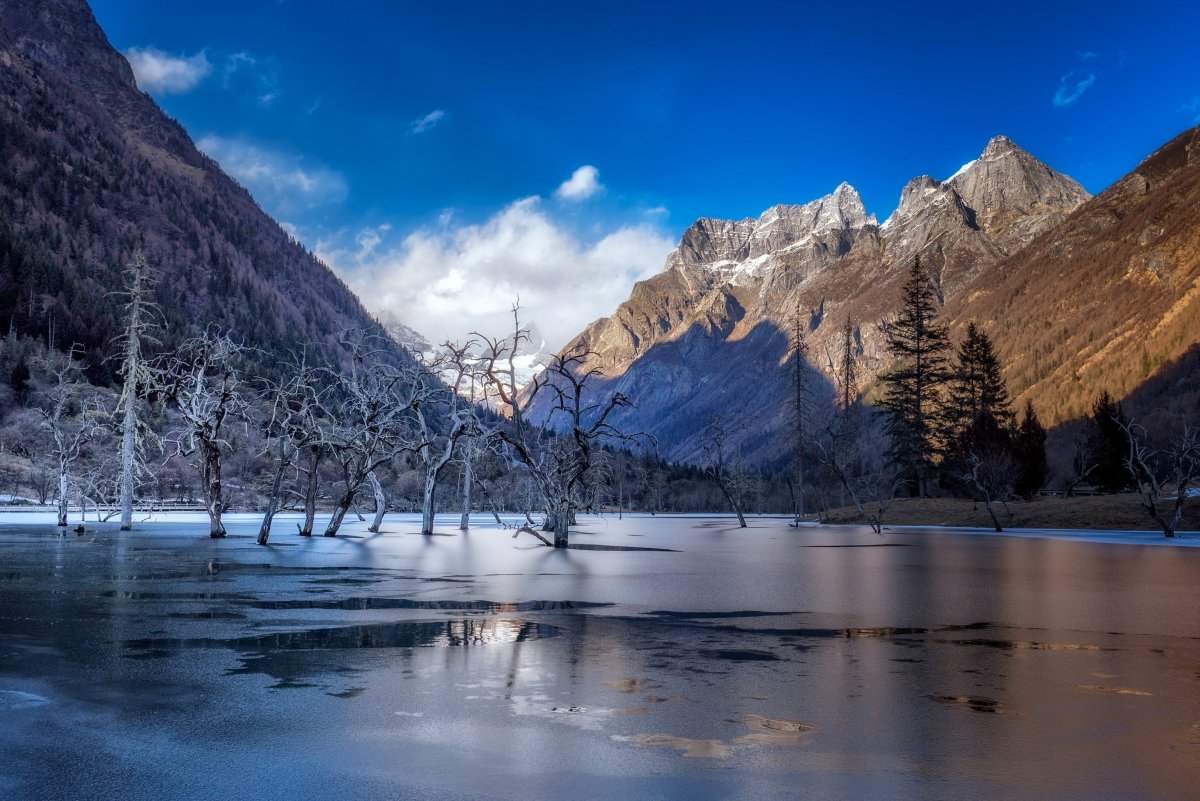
[196,135,348,217]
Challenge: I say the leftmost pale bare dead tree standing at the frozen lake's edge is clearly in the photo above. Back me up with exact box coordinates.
[37,349,103,526]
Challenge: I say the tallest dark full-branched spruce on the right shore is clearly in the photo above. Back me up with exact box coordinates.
[880,258,950,498]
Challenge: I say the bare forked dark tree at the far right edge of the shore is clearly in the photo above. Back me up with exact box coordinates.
[1117,420,1200,537]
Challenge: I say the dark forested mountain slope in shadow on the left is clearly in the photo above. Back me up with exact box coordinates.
[0,0,405,383]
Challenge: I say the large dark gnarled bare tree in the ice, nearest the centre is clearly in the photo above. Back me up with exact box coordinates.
[475,305,652,548]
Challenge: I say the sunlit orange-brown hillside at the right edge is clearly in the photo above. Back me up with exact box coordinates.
[947,128,1200,424]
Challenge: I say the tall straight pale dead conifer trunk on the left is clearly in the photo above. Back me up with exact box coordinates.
[114,251,158,531]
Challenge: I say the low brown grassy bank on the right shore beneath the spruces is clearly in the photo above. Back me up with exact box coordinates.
[828,494,1200,531]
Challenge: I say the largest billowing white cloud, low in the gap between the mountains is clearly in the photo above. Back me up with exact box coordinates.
[314,197,674,348]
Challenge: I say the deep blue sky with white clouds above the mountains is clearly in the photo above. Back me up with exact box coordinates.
[92,0,1200,345]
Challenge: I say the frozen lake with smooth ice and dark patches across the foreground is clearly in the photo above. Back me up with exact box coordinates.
[0,516,1200,801]
